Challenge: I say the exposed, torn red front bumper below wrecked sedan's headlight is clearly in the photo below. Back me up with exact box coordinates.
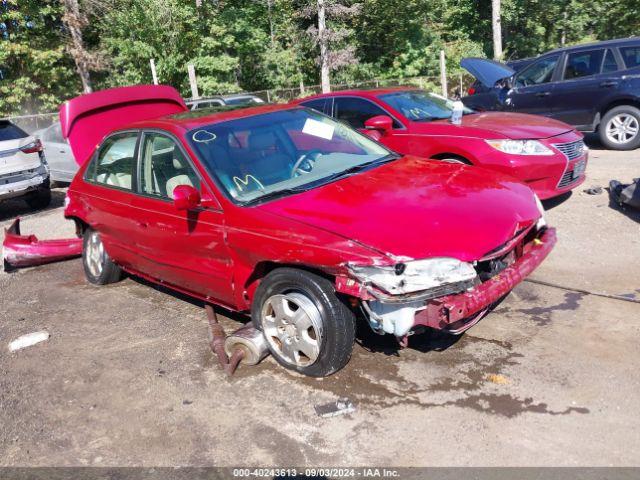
[336,228,556,341]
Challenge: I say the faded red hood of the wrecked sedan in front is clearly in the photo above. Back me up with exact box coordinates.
[257,157,540,261]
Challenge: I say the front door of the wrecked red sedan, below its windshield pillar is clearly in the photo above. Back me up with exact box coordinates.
[127,131,233,304]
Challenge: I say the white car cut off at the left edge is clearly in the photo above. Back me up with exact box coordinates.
[0,120,51,208]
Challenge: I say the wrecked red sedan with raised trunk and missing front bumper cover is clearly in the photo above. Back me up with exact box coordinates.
[61,86,555,376]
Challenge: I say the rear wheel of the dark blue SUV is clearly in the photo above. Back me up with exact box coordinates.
[599,105,640,150]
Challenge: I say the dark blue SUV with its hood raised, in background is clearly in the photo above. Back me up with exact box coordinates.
[461,37,640,150]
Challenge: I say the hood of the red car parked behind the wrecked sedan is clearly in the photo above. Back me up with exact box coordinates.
[439,112,573,140]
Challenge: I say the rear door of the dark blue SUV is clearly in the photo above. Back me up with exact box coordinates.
[552,48,620,130]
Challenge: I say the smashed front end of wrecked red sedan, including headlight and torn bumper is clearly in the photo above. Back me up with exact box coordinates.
[336,224,556,345]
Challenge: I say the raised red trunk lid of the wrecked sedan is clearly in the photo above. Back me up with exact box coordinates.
[60,85,188,165]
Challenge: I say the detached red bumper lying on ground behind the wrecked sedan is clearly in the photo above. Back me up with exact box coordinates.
[2,218,82,270]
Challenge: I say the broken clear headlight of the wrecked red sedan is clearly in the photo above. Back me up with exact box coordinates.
[348,257,476,295]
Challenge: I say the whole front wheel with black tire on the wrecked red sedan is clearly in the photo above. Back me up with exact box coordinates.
[251,268,356,377]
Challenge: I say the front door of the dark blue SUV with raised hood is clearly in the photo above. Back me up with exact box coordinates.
[504,54,561,116]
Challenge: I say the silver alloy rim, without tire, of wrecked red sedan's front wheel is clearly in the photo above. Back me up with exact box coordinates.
[261,292,322,367]
